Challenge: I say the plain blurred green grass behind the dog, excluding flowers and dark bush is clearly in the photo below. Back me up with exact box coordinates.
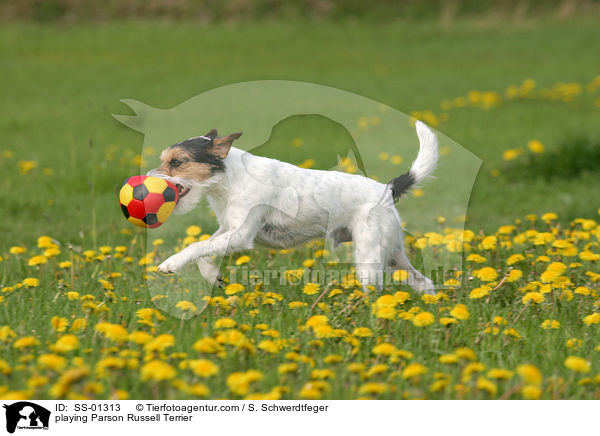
[0,19,600,249]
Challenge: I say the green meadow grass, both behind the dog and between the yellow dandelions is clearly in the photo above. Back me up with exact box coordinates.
[0,17,600,398]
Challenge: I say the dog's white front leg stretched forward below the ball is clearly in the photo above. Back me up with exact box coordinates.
[158,209,259,274]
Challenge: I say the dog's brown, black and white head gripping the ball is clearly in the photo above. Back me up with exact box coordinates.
[147,129,242,214]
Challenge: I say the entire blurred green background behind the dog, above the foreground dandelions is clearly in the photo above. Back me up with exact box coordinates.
[0,0,600,251]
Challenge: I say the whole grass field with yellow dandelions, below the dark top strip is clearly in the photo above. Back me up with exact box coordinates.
[0,17,600,398]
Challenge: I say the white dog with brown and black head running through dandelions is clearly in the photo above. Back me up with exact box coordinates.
[148,121,438,293]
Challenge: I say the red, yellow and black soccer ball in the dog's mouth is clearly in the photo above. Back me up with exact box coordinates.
[119,176,179,229]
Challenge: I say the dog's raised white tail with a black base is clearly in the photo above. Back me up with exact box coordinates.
[389,121,438,201]
